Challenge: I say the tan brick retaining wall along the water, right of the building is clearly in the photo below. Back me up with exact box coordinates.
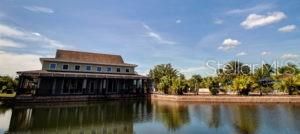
[151,94,300,103]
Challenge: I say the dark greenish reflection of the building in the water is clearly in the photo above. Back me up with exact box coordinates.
[9,101,151,134]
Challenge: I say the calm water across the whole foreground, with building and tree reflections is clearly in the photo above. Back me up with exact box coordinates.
[0,100,300,134]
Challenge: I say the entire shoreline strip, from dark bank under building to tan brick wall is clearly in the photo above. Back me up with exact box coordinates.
[2,94,300,104]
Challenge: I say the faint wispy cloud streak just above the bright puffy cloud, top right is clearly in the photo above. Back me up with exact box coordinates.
[226,4,275,14]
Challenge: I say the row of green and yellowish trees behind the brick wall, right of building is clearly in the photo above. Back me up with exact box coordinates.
[149,61,300,95]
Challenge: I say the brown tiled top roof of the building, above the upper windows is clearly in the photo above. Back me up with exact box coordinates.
[55,50,124,64]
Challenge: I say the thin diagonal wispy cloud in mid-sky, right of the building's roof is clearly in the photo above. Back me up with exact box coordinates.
[143,24,177,45]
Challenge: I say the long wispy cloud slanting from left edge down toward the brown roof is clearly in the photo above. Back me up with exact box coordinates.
[0,23,70,48]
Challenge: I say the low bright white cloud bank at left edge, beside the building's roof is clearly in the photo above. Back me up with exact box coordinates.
[0,51,41,76]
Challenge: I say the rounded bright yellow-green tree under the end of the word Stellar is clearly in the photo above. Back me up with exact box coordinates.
[232,75,254,95]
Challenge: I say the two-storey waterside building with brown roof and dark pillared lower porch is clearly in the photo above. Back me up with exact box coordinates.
[17,50,150,96]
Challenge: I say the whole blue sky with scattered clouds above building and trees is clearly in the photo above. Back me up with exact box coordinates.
[0,0,300,77]
